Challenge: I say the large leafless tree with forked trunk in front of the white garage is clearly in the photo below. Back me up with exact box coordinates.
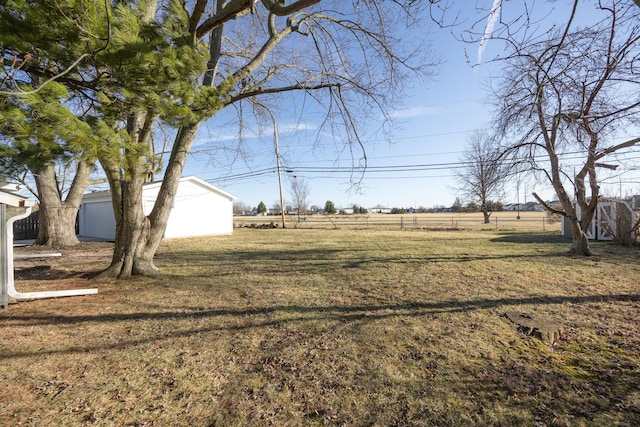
[94,0,433,277]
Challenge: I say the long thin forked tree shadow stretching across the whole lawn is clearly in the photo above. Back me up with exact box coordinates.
[3,294,640,358]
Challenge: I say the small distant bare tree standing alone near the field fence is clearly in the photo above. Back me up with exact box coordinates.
[455,130,506,224]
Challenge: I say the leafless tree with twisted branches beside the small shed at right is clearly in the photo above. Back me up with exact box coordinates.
[484,0,640,255]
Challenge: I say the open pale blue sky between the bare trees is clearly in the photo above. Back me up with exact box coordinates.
[94,0,640,208]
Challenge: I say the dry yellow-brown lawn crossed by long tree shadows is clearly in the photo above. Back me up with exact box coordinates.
[0,228,640,426]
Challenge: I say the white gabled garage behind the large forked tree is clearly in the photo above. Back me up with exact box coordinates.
[78,176,236,240]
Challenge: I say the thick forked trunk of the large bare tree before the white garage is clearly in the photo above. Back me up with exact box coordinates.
[99,122,200,278]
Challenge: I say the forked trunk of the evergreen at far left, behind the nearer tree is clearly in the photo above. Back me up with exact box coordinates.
[34,161,91,246]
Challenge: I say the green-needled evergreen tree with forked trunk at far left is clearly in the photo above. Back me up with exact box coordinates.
[0,0,204,245]
